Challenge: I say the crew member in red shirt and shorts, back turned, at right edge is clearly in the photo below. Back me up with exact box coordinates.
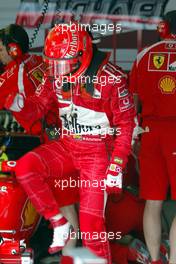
[130,11,176,263]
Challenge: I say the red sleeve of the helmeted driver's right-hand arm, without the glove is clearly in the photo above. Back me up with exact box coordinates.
[111,76,136,165]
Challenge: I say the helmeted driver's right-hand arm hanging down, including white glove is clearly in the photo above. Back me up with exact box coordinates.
[106,76,135,193]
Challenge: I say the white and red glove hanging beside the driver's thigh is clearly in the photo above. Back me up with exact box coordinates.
[105,163,122,194]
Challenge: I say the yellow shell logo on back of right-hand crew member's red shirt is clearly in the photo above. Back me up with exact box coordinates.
[158,75,176,94]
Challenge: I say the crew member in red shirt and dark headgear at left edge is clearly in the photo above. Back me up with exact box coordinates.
[0,24,50,134]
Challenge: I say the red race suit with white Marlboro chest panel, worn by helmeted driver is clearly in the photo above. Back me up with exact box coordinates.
[12,53,135,263]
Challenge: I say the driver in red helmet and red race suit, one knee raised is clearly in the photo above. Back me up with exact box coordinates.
[5,23,135,263]
